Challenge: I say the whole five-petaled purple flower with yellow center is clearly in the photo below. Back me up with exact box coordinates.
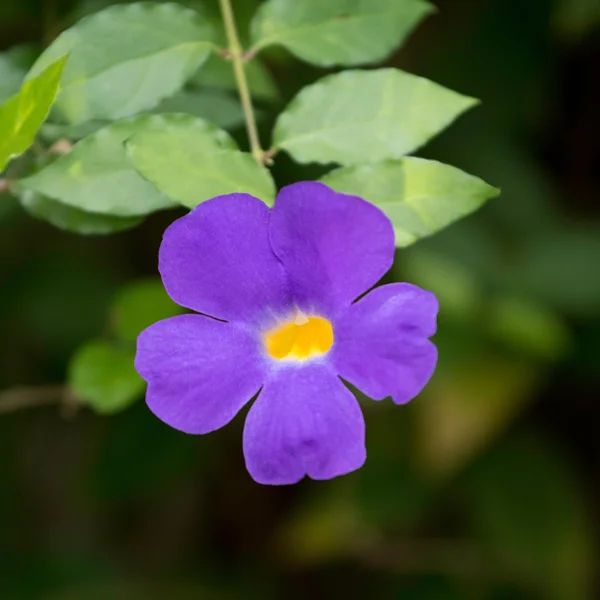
[136,182,438,484]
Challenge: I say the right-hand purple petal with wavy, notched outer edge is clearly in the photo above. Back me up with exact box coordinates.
[331,283,438,404]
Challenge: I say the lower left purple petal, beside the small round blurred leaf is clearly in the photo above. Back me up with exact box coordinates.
[135,315,265,433]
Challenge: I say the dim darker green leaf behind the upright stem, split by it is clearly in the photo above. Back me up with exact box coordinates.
[190,54,279,100]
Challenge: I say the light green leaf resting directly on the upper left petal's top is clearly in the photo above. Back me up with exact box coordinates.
[127,119,275,208]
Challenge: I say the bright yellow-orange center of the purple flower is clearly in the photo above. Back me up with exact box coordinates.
[264,311,333,360]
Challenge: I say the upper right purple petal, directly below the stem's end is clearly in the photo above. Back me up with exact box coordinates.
[271,182,395,314]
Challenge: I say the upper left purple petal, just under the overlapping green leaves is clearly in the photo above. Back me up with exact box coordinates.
[159,194,289,321]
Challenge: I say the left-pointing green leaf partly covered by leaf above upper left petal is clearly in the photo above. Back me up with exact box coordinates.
[19,115,188,217]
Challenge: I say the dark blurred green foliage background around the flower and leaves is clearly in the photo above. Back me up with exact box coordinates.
[0,0,600,600]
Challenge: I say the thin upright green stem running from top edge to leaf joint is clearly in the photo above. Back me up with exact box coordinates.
[219,0,264,165]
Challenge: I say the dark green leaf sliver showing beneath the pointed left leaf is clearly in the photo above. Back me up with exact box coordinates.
[19,190,142,235]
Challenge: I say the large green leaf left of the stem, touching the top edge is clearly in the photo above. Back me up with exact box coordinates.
[29,2,215,124]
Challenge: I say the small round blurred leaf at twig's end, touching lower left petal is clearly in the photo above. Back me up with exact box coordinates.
[68,341,145,414]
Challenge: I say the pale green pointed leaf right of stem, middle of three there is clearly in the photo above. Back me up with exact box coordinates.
[273,69,477,165]
